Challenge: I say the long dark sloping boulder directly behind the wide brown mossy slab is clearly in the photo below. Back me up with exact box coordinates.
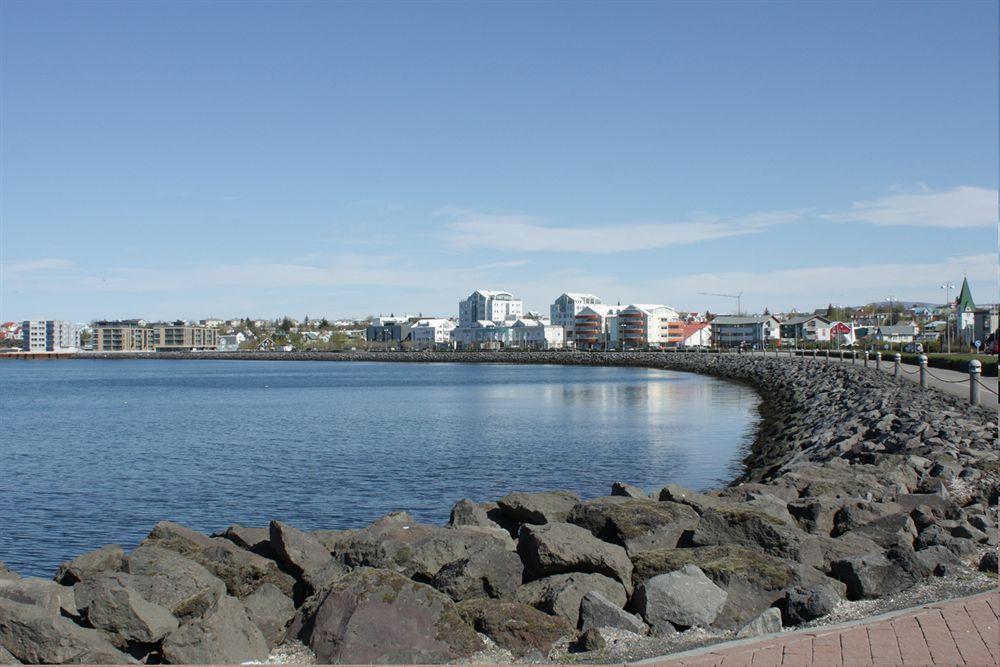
[691,508,823,567]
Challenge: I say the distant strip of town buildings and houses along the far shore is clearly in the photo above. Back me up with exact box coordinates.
[0,280,998,354]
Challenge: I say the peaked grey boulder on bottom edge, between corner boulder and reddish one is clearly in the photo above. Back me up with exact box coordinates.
[163,595,270,665]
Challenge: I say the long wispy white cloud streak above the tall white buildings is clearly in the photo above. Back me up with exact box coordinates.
[444,209,806,254]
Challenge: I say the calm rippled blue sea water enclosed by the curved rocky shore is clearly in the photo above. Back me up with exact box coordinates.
[0,360,758,576]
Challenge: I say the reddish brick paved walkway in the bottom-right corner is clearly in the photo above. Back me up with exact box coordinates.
[645,591,1000,667]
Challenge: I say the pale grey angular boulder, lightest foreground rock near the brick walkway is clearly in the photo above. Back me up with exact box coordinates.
[631,565,726,634]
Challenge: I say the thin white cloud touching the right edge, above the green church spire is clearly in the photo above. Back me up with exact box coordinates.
[823,185,997,228]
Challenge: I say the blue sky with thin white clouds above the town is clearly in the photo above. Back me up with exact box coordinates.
[0,0,1000,320]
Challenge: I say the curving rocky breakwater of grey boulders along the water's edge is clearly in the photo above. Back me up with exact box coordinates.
[0,353,1000,664]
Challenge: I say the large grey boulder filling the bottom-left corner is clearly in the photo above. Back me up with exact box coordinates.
[0,599,135,665]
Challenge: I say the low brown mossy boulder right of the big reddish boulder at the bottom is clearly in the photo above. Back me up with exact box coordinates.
[458,599,573,659]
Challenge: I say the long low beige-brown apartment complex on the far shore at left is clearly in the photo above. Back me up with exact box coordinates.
[92,320,219,352]
